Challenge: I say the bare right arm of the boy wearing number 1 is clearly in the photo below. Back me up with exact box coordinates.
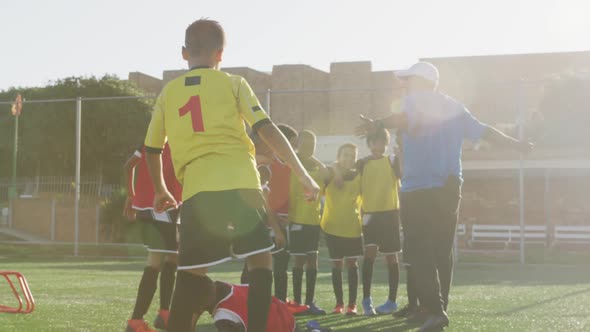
[256,121,320,200]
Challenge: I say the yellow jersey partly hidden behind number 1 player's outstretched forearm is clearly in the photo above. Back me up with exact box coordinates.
[289,168,323,225]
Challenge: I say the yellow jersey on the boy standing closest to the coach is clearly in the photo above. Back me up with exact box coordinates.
[359,156,400,213]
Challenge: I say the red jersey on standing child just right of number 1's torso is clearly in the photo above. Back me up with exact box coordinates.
[268,160,291,214]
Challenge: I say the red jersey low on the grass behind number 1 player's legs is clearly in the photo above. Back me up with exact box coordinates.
[212,285,295,332]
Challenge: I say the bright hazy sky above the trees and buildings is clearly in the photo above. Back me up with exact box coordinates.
[0,0,590,90]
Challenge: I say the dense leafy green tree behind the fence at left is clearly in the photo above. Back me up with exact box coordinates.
[0,75,153,183]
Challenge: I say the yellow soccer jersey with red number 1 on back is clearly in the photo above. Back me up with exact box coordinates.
[145,68,270,201]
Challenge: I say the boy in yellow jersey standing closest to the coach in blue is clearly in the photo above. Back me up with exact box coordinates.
[357,129,401,316]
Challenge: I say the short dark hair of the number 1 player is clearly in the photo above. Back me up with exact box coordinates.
[184,18,225,56]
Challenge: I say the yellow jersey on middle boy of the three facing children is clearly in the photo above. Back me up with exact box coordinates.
[321,174,362,238]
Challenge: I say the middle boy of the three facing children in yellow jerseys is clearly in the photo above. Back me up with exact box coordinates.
[321,143,363,315]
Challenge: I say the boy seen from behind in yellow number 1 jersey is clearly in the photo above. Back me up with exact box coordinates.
[145,19,319,332]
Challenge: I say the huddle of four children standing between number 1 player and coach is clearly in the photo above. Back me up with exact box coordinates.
[242,125,408,316]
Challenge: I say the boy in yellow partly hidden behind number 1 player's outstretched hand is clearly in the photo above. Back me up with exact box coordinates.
[289,130,327,315]
